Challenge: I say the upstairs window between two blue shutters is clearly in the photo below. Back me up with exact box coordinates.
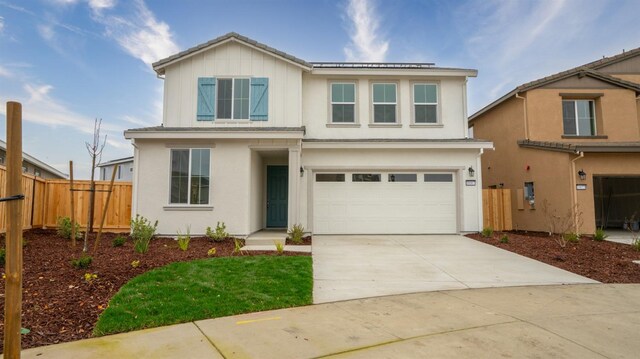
[216,78,250,120]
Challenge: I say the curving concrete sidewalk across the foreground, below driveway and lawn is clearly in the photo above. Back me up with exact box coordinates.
[23,284,640,358]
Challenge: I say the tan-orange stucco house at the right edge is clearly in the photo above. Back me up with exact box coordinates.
[469,49,640,233]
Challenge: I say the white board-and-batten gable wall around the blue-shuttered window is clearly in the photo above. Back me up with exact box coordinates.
[163,42,302,127]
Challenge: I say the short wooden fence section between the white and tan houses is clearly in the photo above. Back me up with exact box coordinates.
[482,189,513,231]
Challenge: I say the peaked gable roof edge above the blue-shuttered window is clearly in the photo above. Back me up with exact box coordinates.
[151,32,313,75]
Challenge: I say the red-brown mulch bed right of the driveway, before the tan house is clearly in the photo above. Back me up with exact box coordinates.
[467,232,640,283]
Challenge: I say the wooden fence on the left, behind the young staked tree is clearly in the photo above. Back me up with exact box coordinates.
[0,166,132,233]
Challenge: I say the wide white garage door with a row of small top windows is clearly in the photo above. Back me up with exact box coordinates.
[313,172,457,234]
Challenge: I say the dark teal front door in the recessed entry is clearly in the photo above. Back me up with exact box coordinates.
[267,166,289,228]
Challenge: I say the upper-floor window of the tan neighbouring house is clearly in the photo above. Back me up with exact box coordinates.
[562,100,596,136]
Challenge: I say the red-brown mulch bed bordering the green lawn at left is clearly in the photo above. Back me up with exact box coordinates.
[0,229,309,352]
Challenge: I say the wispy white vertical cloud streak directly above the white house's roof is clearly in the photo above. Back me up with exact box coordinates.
[344,0,389,62]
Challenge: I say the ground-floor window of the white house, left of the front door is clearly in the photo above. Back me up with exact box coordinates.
[169,148,211,204]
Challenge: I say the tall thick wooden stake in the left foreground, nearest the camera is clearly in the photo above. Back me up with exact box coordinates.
[4,102,22,358]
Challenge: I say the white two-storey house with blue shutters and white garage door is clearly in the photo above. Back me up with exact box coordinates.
[125,33,492,236]
